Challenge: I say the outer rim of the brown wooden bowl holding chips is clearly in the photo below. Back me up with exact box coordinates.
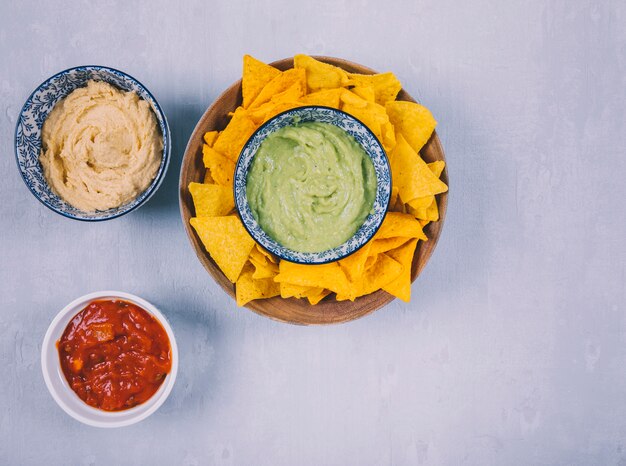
[178,56,450,325]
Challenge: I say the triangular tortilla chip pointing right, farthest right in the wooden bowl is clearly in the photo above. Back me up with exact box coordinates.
[390,135,448,199]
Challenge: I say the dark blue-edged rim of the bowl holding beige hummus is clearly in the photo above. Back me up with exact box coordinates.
[13,65,172,222]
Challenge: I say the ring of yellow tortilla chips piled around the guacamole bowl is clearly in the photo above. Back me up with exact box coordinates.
[189,55,448,306]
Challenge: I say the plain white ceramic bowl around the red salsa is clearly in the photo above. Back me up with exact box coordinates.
[41,291,178,427]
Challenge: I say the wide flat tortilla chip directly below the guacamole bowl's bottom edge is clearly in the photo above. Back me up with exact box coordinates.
[274,260,350,294]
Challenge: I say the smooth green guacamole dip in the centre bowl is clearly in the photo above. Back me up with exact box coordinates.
[246,122,377,252]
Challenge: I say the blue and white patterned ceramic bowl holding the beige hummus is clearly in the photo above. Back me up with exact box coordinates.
[15,66,171,222]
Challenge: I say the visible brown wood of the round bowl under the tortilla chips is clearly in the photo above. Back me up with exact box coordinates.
[179,57,448,325]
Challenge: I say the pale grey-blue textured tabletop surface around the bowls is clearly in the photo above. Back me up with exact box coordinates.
[0,0,626,465]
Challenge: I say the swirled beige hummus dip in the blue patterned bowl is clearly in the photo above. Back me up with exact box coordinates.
[39,81,163,211]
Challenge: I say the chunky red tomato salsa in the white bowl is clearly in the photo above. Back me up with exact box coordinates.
[57,300,172,411]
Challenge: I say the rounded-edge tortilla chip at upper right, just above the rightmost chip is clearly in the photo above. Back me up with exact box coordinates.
[385,100,437,152]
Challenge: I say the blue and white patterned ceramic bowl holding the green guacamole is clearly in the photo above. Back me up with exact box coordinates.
[234,106,391,264]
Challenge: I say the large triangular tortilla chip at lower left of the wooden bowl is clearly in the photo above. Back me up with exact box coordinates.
[189,215,254,283]
